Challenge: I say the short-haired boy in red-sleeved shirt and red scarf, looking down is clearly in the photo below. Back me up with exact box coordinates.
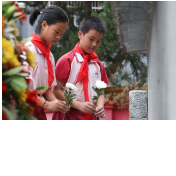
[52,16,109,120]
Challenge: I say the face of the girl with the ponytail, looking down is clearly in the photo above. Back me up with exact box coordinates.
[41,21,67,45]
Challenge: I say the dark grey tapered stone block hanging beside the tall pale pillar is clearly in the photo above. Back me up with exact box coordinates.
[111,1,152,54]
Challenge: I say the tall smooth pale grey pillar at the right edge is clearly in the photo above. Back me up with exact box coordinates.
[148,1,176,120]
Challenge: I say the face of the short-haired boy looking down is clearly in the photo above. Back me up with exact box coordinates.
[78,29,103,54]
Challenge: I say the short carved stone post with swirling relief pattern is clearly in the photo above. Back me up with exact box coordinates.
[129,90,147,120]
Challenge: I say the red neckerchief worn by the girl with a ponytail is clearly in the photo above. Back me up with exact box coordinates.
[31,33,54,93]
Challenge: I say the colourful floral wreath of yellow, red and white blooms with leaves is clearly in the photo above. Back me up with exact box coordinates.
[2,1,46,120]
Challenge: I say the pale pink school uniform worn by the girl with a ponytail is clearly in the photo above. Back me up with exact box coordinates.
[25,34,57,120]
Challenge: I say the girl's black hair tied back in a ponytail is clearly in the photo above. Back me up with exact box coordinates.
[29,5,69,34]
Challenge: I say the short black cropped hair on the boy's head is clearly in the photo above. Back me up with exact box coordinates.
[80,16,106,35]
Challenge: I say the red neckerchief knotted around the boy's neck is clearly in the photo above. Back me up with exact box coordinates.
[73,43,98,120]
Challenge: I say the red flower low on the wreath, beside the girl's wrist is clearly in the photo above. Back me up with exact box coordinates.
[26,90,40,108]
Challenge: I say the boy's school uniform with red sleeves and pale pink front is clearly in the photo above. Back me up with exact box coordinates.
[52,43,109,120]
